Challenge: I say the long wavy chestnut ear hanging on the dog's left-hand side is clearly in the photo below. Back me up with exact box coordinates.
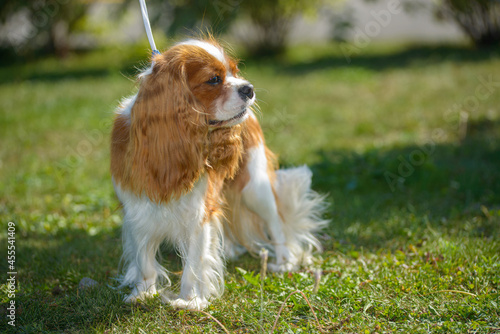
[129,52,208,202]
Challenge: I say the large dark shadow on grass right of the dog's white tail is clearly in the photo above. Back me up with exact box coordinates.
[311,120,500,250]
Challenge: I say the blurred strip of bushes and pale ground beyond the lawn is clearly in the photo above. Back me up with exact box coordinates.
[0,0,500,57]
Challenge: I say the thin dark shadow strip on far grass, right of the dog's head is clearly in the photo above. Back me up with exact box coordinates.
[276,46,500,75]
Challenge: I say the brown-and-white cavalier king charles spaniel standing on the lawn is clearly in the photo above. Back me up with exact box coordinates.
[111,39,327,310]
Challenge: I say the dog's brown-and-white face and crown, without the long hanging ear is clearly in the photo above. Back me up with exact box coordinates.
[142,40,255,128]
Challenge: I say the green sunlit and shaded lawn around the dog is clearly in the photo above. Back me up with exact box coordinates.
[0,40,500,333]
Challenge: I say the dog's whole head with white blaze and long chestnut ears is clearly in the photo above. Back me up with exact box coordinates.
[124,40,255,201]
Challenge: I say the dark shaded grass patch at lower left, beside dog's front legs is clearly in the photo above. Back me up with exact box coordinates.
[0,230,120,333]
